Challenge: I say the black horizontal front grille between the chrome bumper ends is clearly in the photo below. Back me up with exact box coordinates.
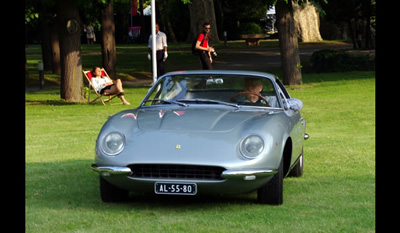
[128,164,225,180]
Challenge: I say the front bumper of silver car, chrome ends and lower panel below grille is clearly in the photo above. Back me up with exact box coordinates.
[92,164,278,194]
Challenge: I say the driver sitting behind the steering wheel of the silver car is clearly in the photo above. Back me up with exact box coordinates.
[231,78,278,107]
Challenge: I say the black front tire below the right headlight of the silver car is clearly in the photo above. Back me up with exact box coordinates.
[257,157,283,205]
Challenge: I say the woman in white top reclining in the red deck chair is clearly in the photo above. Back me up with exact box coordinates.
[91,66,131,105]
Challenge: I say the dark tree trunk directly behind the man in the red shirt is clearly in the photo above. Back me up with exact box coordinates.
[187,0,219,43]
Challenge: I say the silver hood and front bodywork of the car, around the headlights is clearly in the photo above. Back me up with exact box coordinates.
[96,105,284,169]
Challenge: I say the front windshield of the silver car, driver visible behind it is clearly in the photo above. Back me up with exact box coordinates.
[144,74,280,108]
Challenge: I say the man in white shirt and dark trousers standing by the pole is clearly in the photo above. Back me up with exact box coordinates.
[147,23,168,77]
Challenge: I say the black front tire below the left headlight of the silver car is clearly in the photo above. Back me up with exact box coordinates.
[100,176,129,202]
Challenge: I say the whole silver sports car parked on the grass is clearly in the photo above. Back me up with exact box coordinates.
[92,70,308,205]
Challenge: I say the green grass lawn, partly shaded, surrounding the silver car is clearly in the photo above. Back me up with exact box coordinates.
[25,72,375,233]
